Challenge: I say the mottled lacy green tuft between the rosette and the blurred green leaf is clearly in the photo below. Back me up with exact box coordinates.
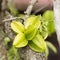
[39,16,48,39]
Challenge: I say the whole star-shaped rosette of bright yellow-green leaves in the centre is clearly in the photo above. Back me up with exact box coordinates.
[11,15,46,52]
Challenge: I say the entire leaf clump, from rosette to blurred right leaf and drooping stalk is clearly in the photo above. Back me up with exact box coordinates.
[11,10,57,56]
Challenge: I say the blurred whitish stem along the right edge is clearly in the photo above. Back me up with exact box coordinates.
[54,0,60,46]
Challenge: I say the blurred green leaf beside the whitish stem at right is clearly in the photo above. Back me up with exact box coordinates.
[43,10,55,35]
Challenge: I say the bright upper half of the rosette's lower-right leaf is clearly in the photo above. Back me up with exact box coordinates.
[32,34,46,49]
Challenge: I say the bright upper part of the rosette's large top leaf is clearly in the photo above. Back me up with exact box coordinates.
[24,15,41,29]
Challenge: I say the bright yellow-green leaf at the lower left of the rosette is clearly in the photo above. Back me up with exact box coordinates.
[13,33,28,48]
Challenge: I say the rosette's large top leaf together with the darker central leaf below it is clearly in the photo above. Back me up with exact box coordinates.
[24,15,41,40]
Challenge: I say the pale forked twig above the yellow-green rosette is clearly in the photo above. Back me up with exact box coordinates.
[2,0,37,22]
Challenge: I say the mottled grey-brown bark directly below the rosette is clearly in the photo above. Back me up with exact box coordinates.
[19,46,47,60]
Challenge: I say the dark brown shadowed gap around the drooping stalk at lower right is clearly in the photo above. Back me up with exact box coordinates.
[47,33,60,60]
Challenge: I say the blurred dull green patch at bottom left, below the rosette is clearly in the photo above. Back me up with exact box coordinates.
[7,47,20,60]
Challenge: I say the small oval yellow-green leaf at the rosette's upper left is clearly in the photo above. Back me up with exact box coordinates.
[11,21,25,33]
